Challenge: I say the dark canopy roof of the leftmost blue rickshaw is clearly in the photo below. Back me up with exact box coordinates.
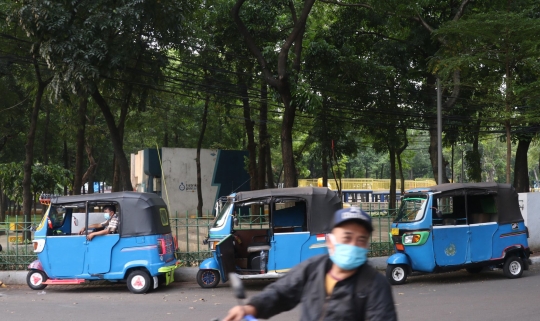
[51,192,171,237]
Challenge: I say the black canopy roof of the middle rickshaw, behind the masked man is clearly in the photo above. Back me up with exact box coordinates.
[235,187,342,235]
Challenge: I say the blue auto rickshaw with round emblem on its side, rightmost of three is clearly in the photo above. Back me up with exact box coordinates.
[386,183,531,284]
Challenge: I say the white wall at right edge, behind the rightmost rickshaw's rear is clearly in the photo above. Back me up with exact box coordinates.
[518,193,540,251]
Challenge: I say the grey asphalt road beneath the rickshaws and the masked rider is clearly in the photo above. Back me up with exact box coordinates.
[0,264,540,321]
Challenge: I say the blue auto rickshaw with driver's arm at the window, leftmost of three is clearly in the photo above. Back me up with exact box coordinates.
[27,192,178,293]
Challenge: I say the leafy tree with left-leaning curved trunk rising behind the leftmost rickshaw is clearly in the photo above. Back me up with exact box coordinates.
[17,0,195,190]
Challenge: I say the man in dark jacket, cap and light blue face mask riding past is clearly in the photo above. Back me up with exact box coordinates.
[223,207,397,321]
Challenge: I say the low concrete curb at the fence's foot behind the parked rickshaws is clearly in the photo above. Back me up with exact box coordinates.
[0,256,540,285]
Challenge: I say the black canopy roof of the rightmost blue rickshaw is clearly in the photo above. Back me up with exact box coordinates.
[428,182,523,224]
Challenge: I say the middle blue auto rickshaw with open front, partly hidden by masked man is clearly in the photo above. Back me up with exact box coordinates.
[197,187,342,288]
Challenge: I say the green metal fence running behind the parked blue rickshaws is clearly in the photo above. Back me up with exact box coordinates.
[0,203,395,270]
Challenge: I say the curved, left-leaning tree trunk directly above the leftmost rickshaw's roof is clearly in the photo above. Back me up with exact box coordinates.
[92,89,133,191]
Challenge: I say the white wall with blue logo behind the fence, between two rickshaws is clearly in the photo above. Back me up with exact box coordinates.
[161,147,218,216]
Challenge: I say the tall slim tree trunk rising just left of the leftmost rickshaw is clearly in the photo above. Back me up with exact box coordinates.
[22,61,50,240]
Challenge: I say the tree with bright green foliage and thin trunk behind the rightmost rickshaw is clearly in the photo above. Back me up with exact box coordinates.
[435,4,540,190]
